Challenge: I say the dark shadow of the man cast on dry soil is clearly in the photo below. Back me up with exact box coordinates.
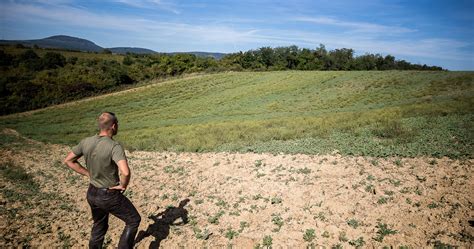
[135,199,189,248]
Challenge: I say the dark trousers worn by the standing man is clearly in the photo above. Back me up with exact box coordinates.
[87,185,141,249]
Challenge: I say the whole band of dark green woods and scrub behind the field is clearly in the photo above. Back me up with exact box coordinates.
[0,45,442,115]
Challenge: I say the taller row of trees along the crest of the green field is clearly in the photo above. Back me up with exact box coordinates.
[221,44,443,71]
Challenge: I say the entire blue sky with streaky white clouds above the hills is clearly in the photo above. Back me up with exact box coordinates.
[0,0,474,70]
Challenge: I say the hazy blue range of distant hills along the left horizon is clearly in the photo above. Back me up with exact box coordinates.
[0,35,225,59]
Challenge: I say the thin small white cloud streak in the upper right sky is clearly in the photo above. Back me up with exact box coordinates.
[294,16,416,34]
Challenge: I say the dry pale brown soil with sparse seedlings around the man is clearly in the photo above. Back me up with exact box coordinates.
[0,131,474,248]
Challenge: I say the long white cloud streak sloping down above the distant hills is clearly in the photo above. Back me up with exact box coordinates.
[2,1,256,43]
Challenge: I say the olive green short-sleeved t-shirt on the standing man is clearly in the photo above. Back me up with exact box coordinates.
[72,135,127,188]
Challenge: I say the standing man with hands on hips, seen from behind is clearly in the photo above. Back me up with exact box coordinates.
[64,112,141,248]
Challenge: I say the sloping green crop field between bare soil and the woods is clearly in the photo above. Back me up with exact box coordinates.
[0,71,474,158]
